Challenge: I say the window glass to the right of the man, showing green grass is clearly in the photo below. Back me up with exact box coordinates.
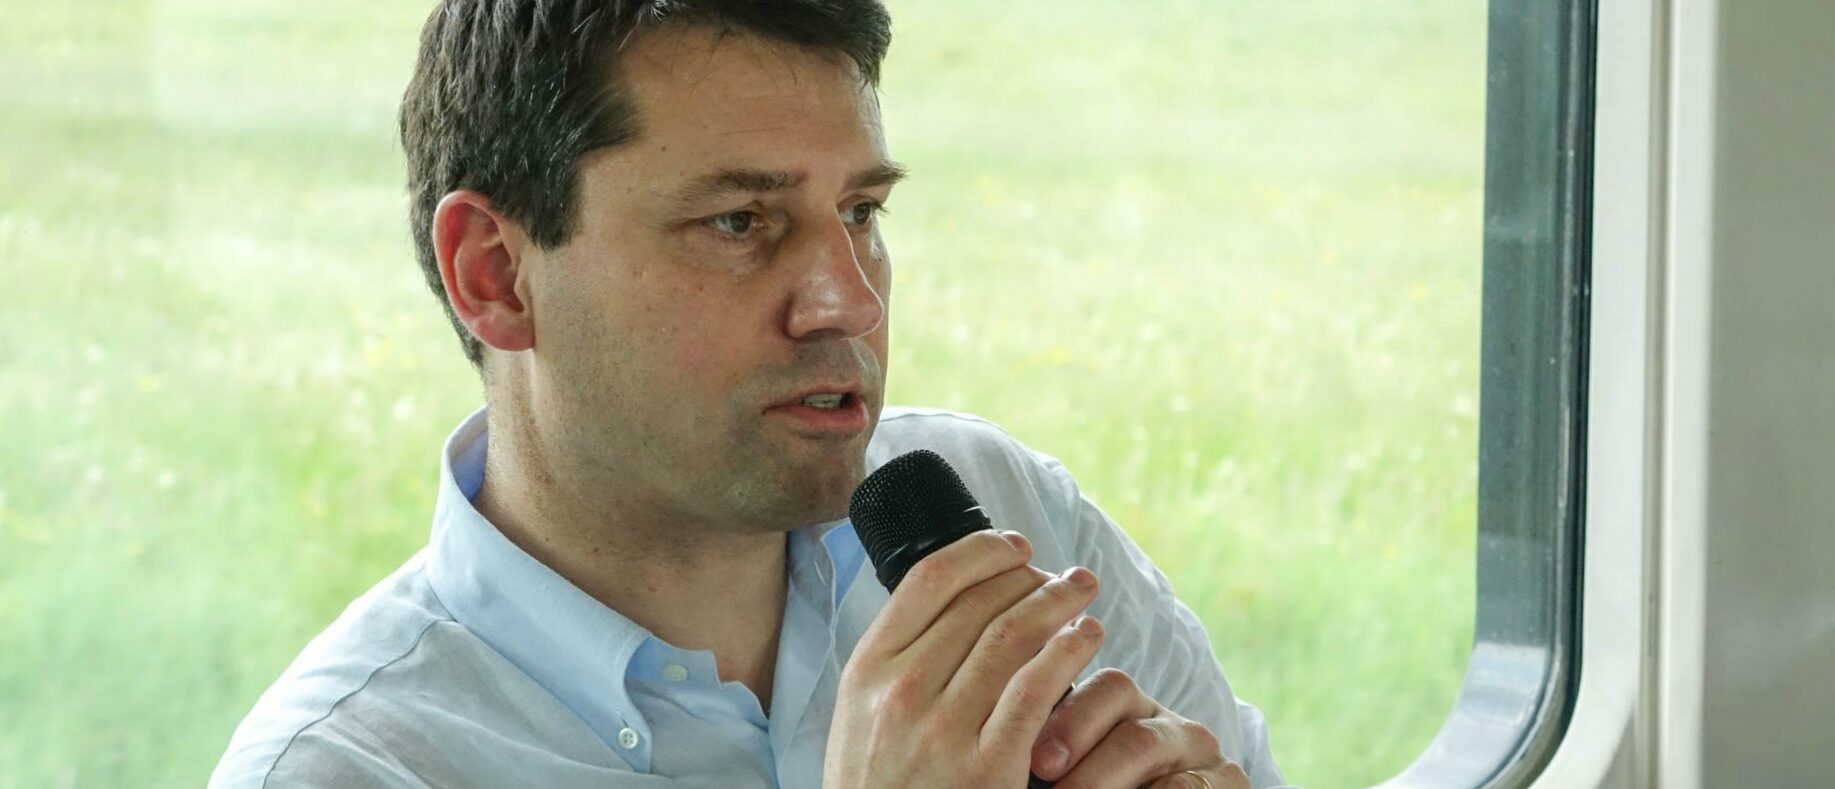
[883,0,1486,787]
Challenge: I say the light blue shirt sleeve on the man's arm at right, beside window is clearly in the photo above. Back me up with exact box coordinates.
[1033,451,1285,789]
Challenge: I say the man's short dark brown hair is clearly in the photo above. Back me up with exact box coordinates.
[400,0,892,371]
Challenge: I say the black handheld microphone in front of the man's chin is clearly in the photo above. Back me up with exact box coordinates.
[848,450,1070,789]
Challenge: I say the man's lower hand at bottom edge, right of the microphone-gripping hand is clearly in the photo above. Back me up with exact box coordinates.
[1031,668,1250,789]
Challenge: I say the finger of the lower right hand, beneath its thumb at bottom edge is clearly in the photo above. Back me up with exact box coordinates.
[1057,714,1229,789]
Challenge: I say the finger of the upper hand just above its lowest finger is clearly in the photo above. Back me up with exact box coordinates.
[945,567,1097,708]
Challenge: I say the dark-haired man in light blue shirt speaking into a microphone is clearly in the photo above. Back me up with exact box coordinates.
[211,0,1279,789]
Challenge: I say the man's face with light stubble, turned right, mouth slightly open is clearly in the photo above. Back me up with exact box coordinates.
[525,28,897,530]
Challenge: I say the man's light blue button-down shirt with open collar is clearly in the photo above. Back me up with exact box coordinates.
[209,409,1281,789]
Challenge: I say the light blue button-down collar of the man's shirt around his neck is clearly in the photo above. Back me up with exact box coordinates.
[428,407,864,772]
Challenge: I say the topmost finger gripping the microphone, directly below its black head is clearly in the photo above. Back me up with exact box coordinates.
[855,530,1031,657]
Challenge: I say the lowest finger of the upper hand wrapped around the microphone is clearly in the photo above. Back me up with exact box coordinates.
[982,617,1103,754]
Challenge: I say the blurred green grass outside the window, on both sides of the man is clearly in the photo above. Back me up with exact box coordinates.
[0,0,1485,789]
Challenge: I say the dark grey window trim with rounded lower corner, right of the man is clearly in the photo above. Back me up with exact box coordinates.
[1385,0,1596,787]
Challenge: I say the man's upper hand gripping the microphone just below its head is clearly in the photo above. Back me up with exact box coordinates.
[822,530,1101,789]
